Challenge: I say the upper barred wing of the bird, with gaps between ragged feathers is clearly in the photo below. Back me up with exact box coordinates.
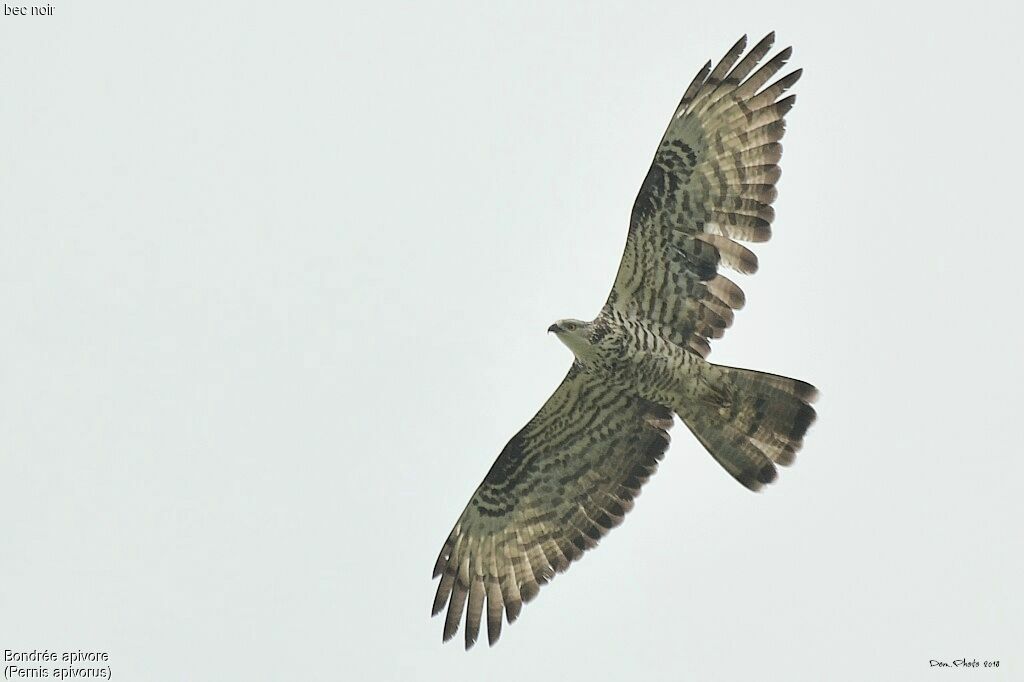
[606,34,801,356]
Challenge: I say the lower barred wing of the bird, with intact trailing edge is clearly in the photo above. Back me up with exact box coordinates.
[433,365,672,648]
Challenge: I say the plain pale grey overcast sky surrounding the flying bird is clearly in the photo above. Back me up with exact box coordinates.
[0,0,1024,682]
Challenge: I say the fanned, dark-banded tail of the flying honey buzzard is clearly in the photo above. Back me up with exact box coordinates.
[677,363,818,491]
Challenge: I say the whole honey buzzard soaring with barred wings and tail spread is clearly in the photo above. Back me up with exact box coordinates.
[433,34,817,648]
